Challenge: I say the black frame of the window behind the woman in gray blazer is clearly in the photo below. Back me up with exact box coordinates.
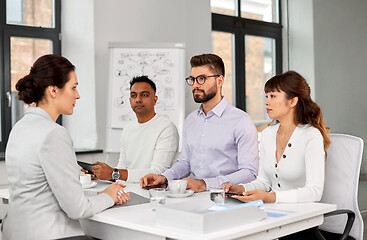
[0,0,61,154]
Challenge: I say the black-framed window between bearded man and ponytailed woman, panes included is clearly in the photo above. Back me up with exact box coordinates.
[211,0,282,125]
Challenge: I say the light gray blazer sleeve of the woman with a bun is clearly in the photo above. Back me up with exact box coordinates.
[39,127,114,219]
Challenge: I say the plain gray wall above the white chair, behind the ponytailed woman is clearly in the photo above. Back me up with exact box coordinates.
[313,0,367,174]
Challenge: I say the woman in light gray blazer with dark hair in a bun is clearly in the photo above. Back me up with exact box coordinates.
[2,55,130,240]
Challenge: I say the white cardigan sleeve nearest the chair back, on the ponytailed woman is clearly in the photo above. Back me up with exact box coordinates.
[275,129,325,203]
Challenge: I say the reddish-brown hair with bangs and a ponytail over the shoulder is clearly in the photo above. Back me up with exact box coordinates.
[264,71,330,152]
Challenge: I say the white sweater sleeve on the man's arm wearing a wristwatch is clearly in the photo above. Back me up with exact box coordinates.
[127,123,179,182]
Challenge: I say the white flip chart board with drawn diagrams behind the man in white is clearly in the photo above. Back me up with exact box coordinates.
[105,43,185,152]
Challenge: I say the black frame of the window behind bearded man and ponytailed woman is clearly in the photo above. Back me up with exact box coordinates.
[212,0,283,111]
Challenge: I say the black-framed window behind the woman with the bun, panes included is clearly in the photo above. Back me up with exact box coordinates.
[0,0,61,152]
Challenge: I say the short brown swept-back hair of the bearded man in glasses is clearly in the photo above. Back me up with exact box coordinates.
[190,53,225,77]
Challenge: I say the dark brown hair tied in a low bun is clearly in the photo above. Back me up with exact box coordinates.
[15,54,75,104]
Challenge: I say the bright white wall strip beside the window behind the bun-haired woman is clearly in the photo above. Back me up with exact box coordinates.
[61,0,97,149]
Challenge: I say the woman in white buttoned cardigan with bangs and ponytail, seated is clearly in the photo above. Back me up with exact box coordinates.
[225,71,330,203]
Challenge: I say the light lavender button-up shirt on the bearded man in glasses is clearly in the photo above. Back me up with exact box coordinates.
[163,97,259,189]
